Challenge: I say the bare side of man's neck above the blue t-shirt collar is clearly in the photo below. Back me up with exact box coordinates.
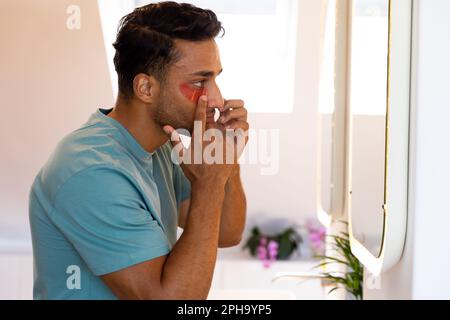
[108,97,168,153]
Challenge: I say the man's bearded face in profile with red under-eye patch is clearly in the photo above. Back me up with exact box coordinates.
[156,40,224,132]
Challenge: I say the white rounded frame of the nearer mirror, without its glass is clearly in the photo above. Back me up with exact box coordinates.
[346,0,413,276]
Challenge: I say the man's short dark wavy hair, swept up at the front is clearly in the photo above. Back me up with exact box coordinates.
[113,1,224,98]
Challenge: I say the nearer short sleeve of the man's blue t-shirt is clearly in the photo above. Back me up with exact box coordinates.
[52,168,170,276]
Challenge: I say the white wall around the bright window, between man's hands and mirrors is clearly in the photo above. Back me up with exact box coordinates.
[242,0,324,231]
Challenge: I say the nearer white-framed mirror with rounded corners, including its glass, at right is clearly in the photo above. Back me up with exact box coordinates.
[347,0,412,275]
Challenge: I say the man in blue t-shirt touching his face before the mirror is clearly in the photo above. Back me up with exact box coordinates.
[30,2,249,299]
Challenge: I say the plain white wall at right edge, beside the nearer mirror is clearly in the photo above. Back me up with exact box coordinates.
[365,0,450,299]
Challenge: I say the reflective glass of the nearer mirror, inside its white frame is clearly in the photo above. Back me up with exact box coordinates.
[349,0,389,257]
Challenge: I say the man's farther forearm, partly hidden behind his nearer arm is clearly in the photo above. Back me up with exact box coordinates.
[219,166,247,248]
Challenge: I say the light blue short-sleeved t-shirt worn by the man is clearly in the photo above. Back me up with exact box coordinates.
[29,110,190,299]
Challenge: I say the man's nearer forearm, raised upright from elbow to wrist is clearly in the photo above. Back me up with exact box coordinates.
[161,182,225,299]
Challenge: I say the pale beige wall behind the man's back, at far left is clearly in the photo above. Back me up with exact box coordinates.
[0,0,113,240]
